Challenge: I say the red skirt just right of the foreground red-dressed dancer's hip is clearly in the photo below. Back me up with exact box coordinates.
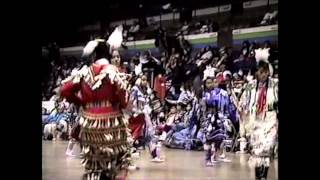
[129,114,145,140]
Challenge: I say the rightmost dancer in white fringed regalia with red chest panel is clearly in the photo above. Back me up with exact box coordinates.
[240,50,278,180]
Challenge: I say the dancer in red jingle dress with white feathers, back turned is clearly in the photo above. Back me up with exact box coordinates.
[60,27,131,180]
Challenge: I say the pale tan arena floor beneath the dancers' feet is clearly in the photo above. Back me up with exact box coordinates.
[42,141,278,180]
